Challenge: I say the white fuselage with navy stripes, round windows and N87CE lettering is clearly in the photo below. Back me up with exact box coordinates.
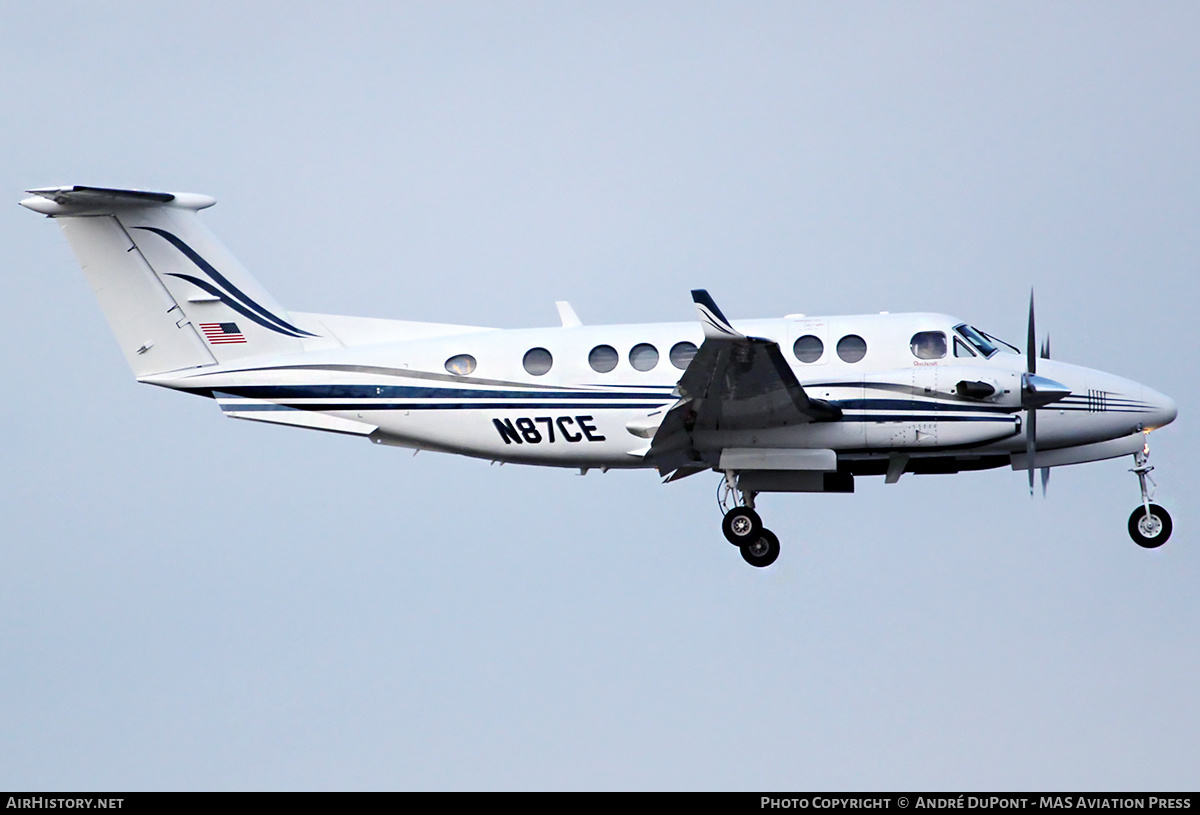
[144,312,1175,473]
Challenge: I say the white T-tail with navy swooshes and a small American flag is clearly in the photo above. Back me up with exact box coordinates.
[20,186,316,377]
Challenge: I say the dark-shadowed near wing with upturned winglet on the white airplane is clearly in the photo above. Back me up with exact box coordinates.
[649,289,841,478]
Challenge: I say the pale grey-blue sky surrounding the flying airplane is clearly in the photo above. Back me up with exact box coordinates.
[0,2,1200,790]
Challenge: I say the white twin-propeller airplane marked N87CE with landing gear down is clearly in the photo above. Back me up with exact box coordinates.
[20,186,1177,567]
